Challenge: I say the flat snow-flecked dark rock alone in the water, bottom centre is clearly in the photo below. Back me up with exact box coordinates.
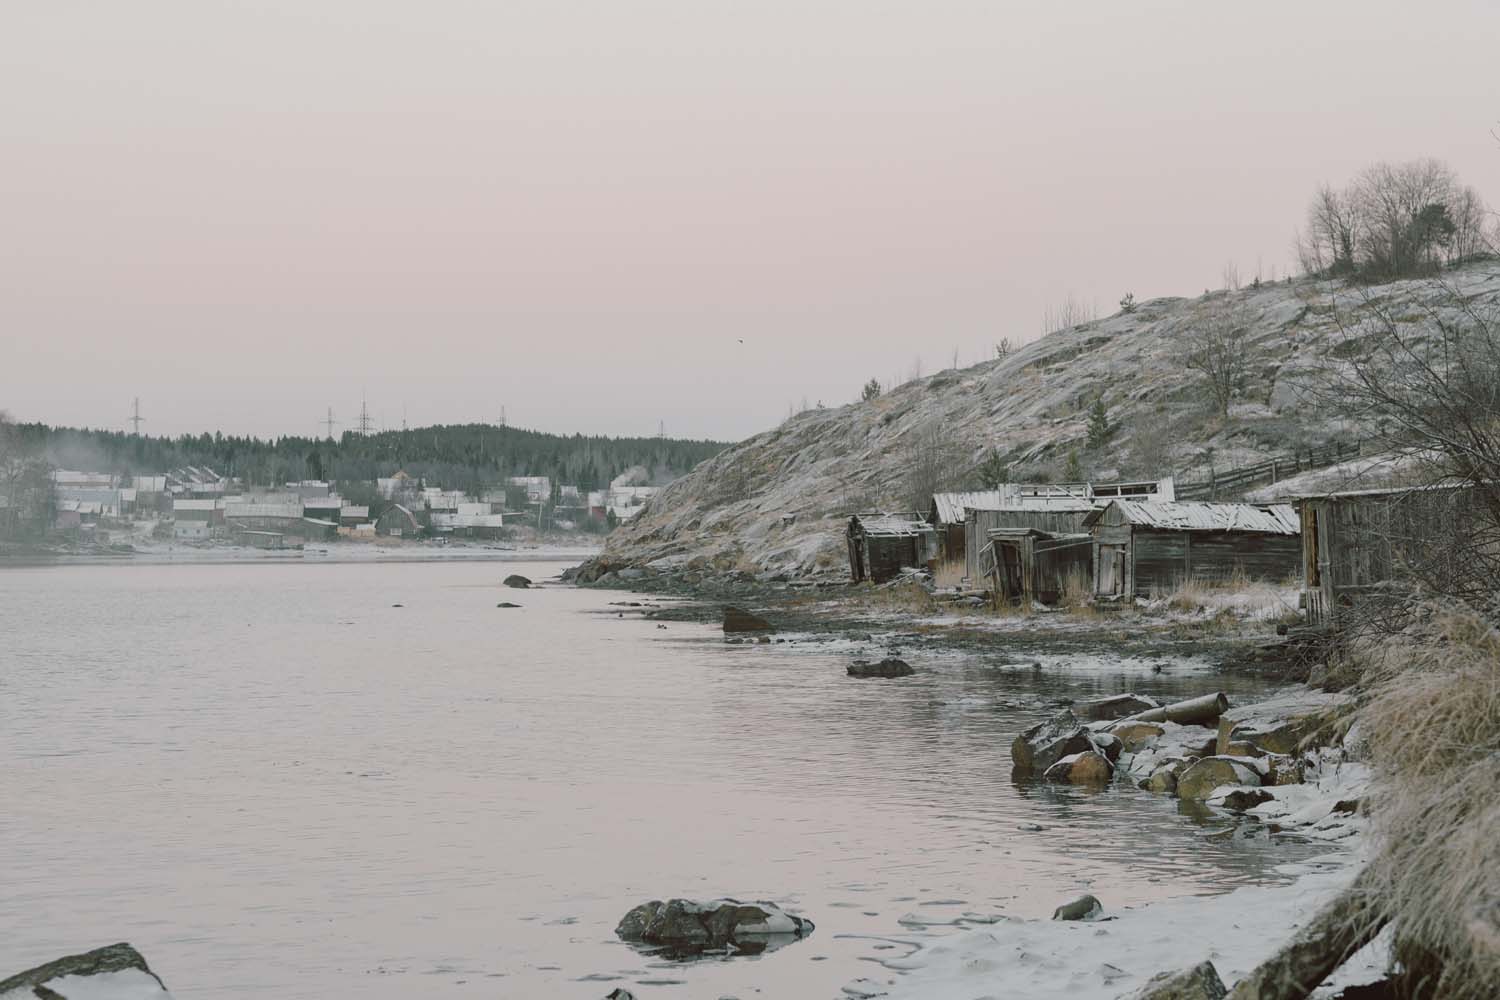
[615,900,813,954]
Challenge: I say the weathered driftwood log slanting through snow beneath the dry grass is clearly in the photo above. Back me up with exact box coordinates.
[1229,876,1386,1000]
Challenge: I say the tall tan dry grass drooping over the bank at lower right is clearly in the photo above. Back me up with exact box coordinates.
[1356,613,1500,1000]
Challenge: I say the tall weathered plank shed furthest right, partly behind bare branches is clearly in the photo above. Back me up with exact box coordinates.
[1298,484,1478,625]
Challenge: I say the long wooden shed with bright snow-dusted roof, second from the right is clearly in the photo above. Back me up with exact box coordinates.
[1085,499,1302,597]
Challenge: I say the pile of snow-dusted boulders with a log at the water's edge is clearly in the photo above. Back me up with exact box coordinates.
[1011,694,1328,810]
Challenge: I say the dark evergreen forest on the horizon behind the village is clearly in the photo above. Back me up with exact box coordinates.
[15,423,728,490]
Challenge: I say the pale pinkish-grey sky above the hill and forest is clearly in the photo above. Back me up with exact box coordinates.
[0,0,1500,439]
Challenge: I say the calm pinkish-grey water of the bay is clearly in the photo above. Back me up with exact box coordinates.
[0,562,1326,1000]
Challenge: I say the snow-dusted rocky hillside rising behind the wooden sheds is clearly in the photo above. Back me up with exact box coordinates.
[584,261,1500,579]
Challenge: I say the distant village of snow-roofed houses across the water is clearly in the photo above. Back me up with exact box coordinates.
[41,466,660,549]
